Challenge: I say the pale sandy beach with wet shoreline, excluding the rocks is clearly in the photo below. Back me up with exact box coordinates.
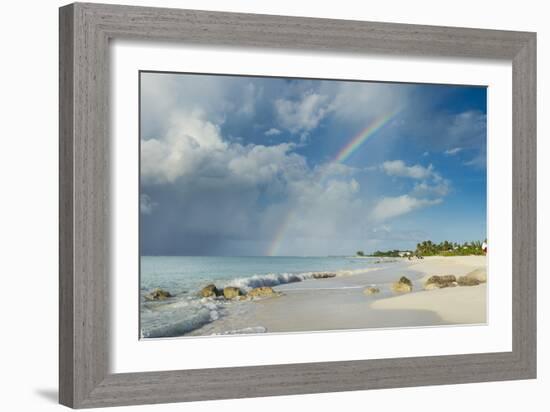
[191,256,486,335]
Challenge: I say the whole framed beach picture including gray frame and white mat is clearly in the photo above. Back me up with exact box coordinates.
[59,3,536,408]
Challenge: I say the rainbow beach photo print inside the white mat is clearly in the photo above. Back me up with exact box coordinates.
[140,71,490,339]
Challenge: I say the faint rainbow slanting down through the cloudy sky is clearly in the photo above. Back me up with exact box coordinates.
[266,110,400,256]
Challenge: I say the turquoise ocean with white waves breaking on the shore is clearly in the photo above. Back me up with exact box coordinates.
[140,256,386,338]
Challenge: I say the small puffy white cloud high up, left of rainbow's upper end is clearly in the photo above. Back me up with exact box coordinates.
[274,91,332,133]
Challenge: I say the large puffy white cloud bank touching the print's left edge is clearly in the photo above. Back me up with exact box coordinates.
[141,107,314,189]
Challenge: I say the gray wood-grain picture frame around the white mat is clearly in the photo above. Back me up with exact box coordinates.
[59,3,536,408]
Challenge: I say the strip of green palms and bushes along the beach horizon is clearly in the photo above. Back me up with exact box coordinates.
[366,240,483,257]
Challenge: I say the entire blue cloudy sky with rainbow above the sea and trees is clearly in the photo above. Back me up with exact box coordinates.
[140,72,487,256]
